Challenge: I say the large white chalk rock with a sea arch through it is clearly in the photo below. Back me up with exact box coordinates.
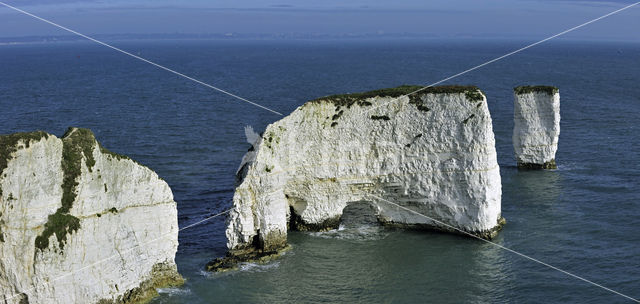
[226,86,501,255]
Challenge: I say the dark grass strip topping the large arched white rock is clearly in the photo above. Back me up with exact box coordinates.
[309,85,482,107]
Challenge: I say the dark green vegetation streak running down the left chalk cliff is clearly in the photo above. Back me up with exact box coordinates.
[35,128,96,250]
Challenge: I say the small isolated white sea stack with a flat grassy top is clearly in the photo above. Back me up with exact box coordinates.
[513,86,560,169]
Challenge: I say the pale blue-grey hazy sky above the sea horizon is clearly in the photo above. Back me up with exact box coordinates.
[0,0,640,42]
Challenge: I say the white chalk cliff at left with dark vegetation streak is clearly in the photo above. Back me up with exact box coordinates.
[0,128,182,303]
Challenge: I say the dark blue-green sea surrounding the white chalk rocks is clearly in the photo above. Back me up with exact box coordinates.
[0,39,640,304]
